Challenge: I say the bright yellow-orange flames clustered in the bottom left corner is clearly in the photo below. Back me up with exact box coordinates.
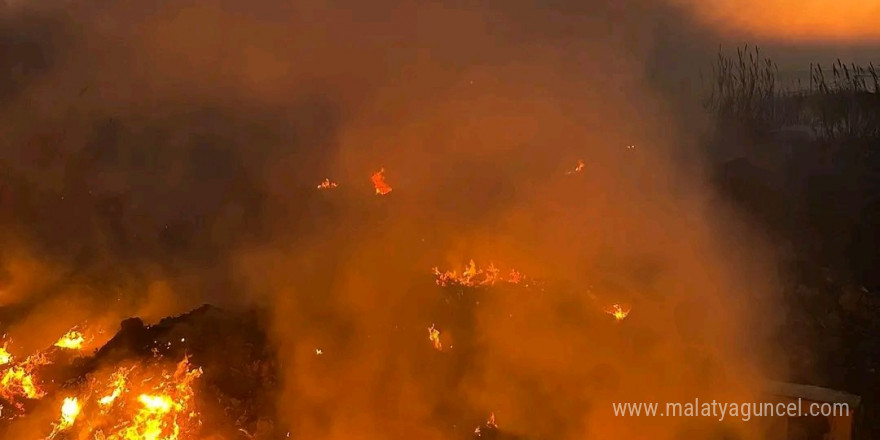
[0,324,202,440]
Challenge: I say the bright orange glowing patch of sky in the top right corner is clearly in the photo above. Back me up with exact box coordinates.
[676,0,880,42]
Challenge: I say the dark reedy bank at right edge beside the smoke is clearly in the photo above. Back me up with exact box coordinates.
[706,47,880,439]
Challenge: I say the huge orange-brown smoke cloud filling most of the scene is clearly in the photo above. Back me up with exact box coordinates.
[0,0,784,439]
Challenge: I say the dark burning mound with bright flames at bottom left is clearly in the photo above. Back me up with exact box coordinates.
[0,307,274,440]
